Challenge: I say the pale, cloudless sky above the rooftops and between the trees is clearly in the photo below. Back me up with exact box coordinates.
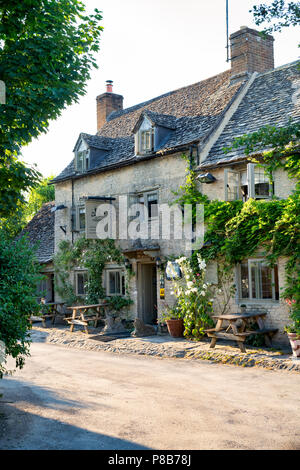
[22,0,299,176]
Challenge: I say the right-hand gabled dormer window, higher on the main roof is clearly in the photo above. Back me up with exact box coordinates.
[133,110,176,156]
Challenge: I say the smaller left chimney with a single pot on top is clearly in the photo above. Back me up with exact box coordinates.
[96,80,123,132]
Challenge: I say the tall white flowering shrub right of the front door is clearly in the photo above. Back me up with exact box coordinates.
[171,254,214,339]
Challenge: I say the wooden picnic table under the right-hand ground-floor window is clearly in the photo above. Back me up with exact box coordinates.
[205,311,278,352]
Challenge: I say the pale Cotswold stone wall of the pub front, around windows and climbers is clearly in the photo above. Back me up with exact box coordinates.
[55,154,294,342]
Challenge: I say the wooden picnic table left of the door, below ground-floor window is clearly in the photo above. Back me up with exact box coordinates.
[65,301,108,334]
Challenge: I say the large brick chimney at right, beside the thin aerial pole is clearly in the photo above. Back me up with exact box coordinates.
[230,26,274,82]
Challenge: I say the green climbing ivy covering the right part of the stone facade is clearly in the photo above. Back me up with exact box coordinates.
[175,123,300,334]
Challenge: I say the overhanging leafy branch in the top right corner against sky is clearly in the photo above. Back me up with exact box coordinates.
[250,0,300,33]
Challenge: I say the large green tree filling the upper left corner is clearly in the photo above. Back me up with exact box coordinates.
[0,0,103,217]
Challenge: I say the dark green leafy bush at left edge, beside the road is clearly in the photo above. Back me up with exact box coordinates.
[0,230,41,378]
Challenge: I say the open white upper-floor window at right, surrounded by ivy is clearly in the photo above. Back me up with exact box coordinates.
[224,163,273,201]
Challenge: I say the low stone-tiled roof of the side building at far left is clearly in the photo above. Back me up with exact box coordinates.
[19,202,55,264]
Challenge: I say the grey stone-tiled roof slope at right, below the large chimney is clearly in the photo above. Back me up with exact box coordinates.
[201,62,300,168]
